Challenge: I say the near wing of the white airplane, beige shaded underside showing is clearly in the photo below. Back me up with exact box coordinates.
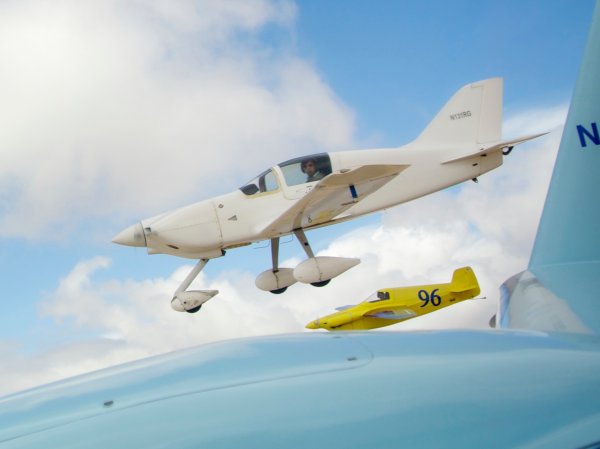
[263,165,408,233]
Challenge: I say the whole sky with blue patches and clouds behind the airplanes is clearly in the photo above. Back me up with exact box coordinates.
[0,0,594,392]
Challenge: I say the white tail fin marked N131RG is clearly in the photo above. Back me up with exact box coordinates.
[415,78,502,146]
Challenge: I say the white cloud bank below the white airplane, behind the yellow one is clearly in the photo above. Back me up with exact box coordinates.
[0,103,566,392]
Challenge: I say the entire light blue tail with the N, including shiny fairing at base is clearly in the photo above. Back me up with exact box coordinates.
[497,3,600,335]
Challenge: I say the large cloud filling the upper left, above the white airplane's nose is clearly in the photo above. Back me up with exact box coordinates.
[0,0,353,239]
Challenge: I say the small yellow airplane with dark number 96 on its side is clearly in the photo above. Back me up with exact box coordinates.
[306,267,480,331]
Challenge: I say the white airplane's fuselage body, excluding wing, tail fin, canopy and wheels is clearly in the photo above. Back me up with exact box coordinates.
[141,146,503,259]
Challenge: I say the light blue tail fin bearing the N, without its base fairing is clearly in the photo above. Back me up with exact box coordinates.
[529,0,600,269]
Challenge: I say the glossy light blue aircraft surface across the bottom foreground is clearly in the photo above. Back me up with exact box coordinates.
[0,331,600,448]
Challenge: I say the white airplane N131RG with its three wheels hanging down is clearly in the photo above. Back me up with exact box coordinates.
[113,78,541,313]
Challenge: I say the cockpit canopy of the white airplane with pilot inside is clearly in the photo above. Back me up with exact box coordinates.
[240,153,331,195]
